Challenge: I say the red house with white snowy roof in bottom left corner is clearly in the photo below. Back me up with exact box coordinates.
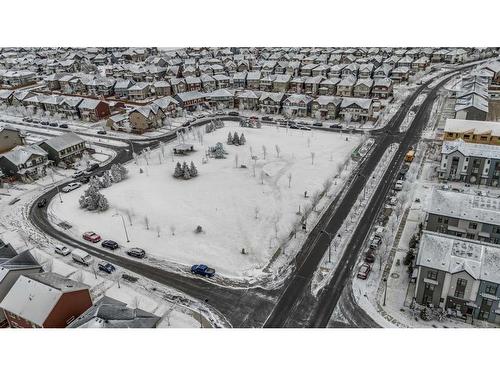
[0,272,92,328]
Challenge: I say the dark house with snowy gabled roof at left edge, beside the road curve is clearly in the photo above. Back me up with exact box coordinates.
[0,145,50,182]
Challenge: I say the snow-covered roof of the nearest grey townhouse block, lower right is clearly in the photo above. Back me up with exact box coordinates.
[416,231,500,284]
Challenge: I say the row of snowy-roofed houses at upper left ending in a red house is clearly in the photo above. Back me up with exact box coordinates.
[0,90,111,122]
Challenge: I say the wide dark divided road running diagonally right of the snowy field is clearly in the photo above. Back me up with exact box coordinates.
[264,61,482,327]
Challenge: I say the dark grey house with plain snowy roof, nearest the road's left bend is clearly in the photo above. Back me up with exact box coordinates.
[39,132,87,165]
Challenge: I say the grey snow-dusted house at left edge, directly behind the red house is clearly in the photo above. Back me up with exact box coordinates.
[0,251,43,328]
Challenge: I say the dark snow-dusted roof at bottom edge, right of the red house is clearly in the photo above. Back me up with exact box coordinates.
[68,296,161,328]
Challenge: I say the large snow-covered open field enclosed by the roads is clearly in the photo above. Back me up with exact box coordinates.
[49,122,360,277]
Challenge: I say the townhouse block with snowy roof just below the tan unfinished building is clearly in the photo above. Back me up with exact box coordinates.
[439,138,500,186]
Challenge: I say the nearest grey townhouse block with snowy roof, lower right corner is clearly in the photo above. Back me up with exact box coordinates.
[415,231,500,324]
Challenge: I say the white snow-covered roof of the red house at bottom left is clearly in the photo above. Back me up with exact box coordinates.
[0,272,88,326]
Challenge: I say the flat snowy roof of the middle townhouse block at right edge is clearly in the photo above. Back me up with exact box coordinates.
[426,188,500,225]
